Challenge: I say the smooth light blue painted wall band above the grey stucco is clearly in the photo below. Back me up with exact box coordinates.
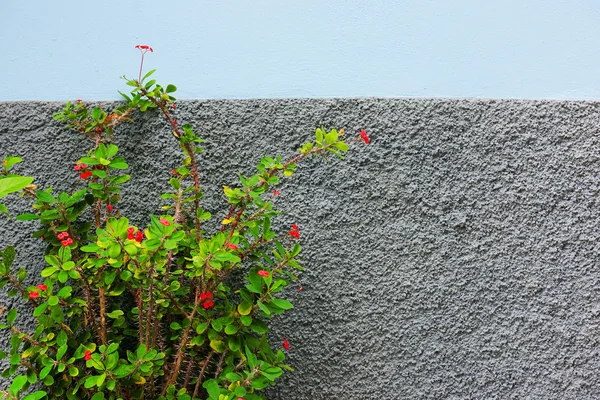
[0,0,600,100]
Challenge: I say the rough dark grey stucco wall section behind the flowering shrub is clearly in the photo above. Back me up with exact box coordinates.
[0,99,600,400]
